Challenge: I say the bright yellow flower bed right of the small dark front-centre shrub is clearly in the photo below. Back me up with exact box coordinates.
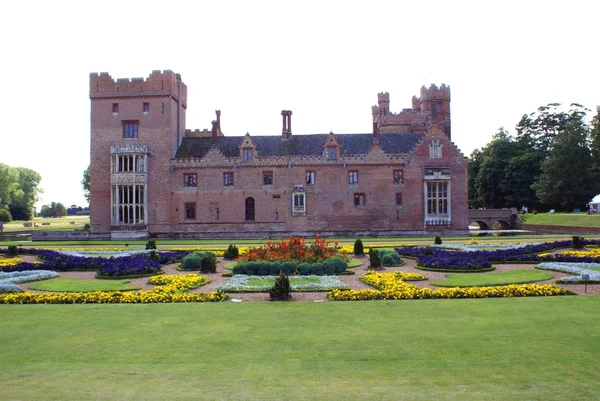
[327,272,573,301]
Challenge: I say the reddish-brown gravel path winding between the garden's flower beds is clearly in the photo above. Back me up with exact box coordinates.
[14,255,600,302]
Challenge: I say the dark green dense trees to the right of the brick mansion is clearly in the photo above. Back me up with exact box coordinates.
[468,103,600,210]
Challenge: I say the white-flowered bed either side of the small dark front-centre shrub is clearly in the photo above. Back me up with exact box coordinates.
[216,274,348,292]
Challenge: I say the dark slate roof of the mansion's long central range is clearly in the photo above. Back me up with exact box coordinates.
[175,134,423,159]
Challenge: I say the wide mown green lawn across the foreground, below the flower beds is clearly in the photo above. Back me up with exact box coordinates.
[0,296,600,401]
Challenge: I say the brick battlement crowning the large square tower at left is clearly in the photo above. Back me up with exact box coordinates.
[90,70,187,103]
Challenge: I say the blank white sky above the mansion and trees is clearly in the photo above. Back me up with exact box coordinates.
[0,0,600,206]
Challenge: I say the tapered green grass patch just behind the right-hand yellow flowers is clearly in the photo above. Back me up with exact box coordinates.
[431,270,554,287]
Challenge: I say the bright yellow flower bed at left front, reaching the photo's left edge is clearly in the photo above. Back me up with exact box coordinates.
[0,274,228,304]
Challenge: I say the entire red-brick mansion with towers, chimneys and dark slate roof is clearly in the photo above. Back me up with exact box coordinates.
[90,71,468,238]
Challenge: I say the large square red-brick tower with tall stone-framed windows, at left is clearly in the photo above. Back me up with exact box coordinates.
[90,70,187,237]
